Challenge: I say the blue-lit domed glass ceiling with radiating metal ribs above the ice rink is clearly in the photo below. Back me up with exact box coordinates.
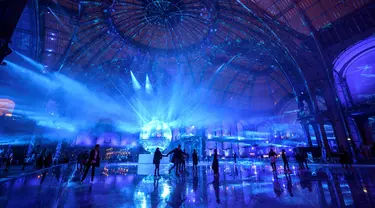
[19,0,371,114]
